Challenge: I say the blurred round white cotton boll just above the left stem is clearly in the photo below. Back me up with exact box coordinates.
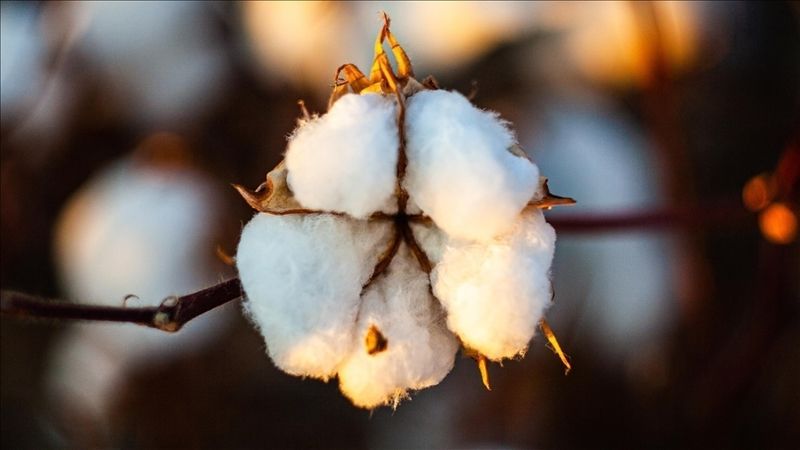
[55,159,228,316]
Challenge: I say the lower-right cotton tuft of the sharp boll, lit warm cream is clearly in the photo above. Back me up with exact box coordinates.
[431,209,556,361]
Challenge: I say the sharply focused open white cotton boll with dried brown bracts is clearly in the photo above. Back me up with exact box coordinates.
[235,18,572,409]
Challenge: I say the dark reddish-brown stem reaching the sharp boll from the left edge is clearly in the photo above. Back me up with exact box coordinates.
[0,278,242,332]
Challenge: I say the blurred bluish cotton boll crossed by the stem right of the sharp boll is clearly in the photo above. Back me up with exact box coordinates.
[527,101,679,370]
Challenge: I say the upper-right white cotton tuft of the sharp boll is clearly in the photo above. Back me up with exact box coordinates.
[404,90,539,241]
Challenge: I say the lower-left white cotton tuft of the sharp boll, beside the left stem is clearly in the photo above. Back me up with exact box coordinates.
[236,213,390,379]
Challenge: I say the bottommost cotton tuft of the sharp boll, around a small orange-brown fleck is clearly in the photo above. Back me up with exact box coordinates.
[339,244,458,408]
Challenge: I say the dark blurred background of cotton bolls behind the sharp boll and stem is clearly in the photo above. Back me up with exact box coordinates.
[0,1,800,449]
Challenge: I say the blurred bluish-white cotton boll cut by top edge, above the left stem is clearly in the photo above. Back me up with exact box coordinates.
[67,1,228,126]
